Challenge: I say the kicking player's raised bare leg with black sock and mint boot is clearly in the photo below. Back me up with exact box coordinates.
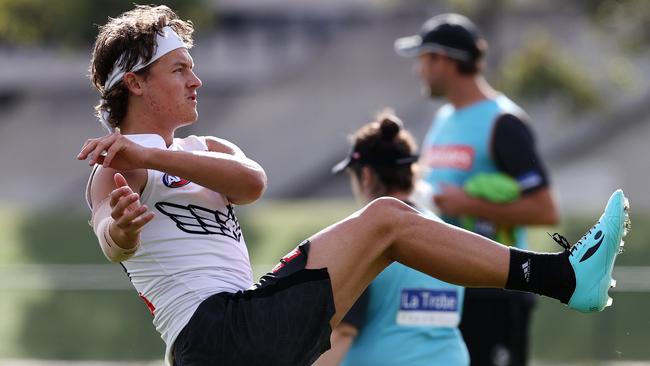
[307,190,630,326]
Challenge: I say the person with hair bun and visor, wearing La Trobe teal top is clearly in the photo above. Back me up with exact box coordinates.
[314,111,469,366]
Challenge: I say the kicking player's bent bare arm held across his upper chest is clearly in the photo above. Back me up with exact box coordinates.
[78,133,266,204]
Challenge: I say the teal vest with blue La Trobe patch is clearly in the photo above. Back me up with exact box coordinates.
[341,209,469,366]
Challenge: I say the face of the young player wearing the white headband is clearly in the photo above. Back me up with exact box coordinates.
[143,48,201,127]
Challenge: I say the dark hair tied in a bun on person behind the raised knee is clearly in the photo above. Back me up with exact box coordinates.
[348,110,417,196]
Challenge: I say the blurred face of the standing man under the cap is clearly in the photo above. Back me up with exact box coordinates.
[416,53,449,98]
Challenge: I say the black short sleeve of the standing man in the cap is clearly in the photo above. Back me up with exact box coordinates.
[491,114,549,194]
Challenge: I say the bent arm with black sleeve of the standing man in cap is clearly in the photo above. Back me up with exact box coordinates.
[434,114,558,225]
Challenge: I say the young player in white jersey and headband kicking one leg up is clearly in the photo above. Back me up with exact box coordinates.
[77,6,628,366]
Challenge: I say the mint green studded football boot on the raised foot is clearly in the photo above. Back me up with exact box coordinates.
[553,189,631,313]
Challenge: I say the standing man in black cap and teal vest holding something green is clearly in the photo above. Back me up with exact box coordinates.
[395,14,558,366]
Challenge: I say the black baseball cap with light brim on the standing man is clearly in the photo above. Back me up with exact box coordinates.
[395,14,481,61]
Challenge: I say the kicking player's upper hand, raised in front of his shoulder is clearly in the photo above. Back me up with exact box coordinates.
[77,131,149,170]
